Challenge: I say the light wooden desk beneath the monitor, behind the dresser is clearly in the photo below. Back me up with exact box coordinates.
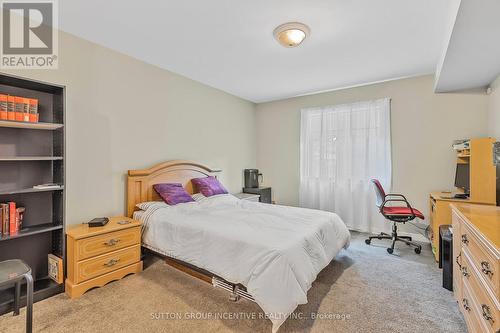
[429,192,493,261]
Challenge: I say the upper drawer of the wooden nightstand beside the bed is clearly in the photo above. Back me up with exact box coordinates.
[75,227,141,261]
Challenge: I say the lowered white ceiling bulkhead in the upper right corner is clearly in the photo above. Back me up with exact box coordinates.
[435,0,500,92]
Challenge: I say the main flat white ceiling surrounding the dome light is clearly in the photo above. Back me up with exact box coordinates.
[59,0,451,102]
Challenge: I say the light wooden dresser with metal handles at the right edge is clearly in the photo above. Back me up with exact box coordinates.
[451,203,500,333]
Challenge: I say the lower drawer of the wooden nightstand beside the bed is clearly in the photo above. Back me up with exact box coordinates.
[74,244,141,283]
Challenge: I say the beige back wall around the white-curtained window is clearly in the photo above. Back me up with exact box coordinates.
[257,76,488,223]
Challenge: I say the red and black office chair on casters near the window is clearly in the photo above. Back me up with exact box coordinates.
[365,179,424,254]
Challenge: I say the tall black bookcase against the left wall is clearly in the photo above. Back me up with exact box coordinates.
[0,74,66,314]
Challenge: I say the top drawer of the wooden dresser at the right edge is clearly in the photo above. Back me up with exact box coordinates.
[460,223,500,298]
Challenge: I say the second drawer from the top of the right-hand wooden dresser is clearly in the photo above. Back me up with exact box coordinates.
[462,249,500,332]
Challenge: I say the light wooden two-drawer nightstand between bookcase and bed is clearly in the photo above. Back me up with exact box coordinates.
[66,216,142,298]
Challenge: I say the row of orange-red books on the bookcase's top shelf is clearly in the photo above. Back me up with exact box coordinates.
[0,94,39,123]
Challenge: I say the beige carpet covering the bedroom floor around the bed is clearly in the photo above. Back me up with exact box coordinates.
[0,233,465,333]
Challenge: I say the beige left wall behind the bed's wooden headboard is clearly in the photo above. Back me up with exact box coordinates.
[1,32,256,223]
